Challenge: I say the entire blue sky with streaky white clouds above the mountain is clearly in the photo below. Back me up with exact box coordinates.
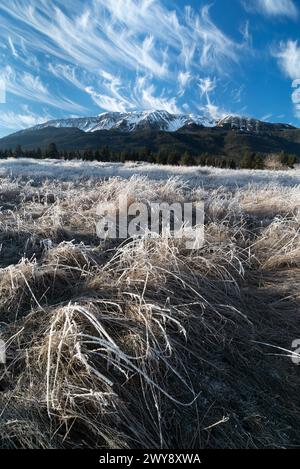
[0,0,300,137]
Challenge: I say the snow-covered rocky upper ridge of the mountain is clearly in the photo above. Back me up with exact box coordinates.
[31,111,216,132]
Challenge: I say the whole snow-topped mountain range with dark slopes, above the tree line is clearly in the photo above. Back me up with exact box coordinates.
[0,111,300,157]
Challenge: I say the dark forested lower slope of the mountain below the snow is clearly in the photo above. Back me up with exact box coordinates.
[0,125,300,158]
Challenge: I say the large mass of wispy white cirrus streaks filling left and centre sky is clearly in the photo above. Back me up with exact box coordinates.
[0,0,251,133]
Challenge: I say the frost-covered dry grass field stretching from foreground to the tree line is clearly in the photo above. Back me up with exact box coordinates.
[0,160,300,449]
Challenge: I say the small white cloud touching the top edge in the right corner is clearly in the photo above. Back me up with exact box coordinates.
[242,0,299,19]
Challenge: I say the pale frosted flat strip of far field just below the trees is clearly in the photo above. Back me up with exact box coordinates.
[0,158,300,187]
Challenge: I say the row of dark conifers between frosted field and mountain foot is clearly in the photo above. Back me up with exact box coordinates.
[0,143,297,169]
